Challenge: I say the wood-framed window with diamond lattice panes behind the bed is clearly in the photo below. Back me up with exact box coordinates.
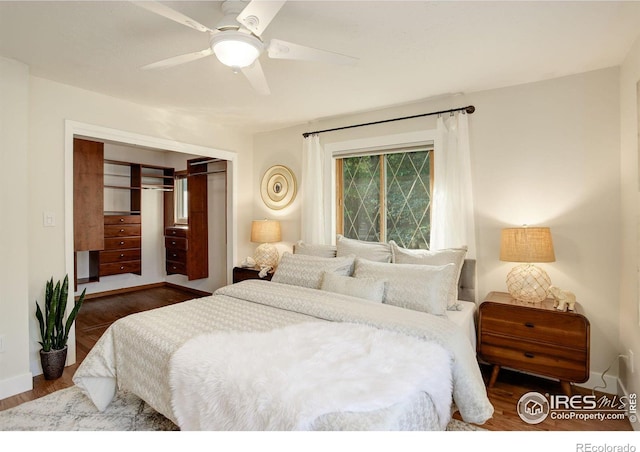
[336,147,433,249]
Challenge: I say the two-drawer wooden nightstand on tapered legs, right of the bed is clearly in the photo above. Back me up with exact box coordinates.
[478,292,590,395]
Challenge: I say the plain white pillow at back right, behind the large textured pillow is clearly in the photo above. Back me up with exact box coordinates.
[389,240,467,310]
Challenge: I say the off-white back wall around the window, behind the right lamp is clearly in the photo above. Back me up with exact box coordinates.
[254,68,620,386]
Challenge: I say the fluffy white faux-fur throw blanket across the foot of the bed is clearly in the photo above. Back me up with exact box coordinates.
[169,322,452,431]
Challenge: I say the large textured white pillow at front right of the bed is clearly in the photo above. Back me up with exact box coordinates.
[353,258,456,316]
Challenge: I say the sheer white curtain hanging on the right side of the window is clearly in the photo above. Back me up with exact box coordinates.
[430,113,476,259]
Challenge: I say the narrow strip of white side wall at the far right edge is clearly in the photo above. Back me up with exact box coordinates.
[619,35,640,430]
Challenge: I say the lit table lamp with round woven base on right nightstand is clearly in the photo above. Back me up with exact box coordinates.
[500,226,556,303]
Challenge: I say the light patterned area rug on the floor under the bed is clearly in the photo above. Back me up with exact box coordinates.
[0,386,484,432]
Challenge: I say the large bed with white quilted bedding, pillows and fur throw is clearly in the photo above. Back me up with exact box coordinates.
[73,237,493,430]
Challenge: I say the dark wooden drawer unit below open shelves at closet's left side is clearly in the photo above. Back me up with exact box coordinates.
[100,215,142,276]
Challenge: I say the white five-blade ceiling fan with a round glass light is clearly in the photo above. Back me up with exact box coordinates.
[132,0,357,95]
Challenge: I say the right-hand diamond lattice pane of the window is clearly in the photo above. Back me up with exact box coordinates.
[386,151,431,249]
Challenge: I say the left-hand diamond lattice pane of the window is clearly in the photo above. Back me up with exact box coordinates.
[343,155,380,242]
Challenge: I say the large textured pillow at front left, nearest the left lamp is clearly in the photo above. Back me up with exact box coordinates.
[271,252,355,289]
